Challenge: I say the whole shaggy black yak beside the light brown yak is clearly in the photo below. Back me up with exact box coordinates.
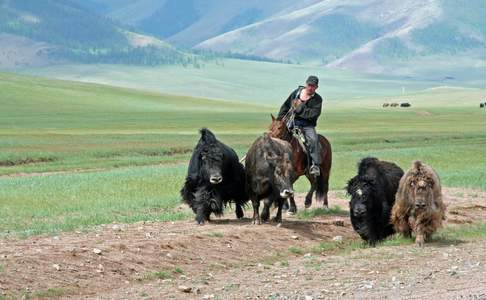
[346,157,403,245]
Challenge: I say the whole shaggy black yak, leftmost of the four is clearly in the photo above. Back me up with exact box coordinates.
[181,128,248,224]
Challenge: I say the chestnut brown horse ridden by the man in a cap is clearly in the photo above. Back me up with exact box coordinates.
[268,115,332,214]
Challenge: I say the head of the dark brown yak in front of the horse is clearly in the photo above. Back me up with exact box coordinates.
[263,134,294,198]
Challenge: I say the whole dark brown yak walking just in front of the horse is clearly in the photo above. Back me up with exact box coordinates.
[245,133,295,226]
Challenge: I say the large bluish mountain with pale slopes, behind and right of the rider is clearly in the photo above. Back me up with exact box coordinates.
[77,0,486,73]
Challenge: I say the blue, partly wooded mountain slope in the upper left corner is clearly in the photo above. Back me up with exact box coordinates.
[0,0,190,68]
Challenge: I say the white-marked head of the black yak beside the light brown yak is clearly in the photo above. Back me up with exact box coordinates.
[346,175,375,217]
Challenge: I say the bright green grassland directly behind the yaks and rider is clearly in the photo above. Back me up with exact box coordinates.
[0,69,486,236]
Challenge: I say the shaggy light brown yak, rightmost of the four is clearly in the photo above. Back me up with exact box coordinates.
[391,161,446,246]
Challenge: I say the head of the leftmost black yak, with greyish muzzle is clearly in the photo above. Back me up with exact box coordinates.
[198,128,224,185]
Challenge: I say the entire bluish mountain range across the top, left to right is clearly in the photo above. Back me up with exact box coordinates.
[6,0,486,75]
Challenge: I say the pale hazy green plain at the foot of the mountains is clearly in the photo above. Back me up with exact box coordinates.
[23,59,462,105]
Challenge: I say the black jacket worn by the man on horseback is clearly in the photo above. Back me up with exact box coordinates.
[277,86,322,127]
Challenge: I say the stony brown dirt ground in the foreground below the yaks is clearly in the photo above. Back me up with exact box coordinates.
[0,189,486,299]
